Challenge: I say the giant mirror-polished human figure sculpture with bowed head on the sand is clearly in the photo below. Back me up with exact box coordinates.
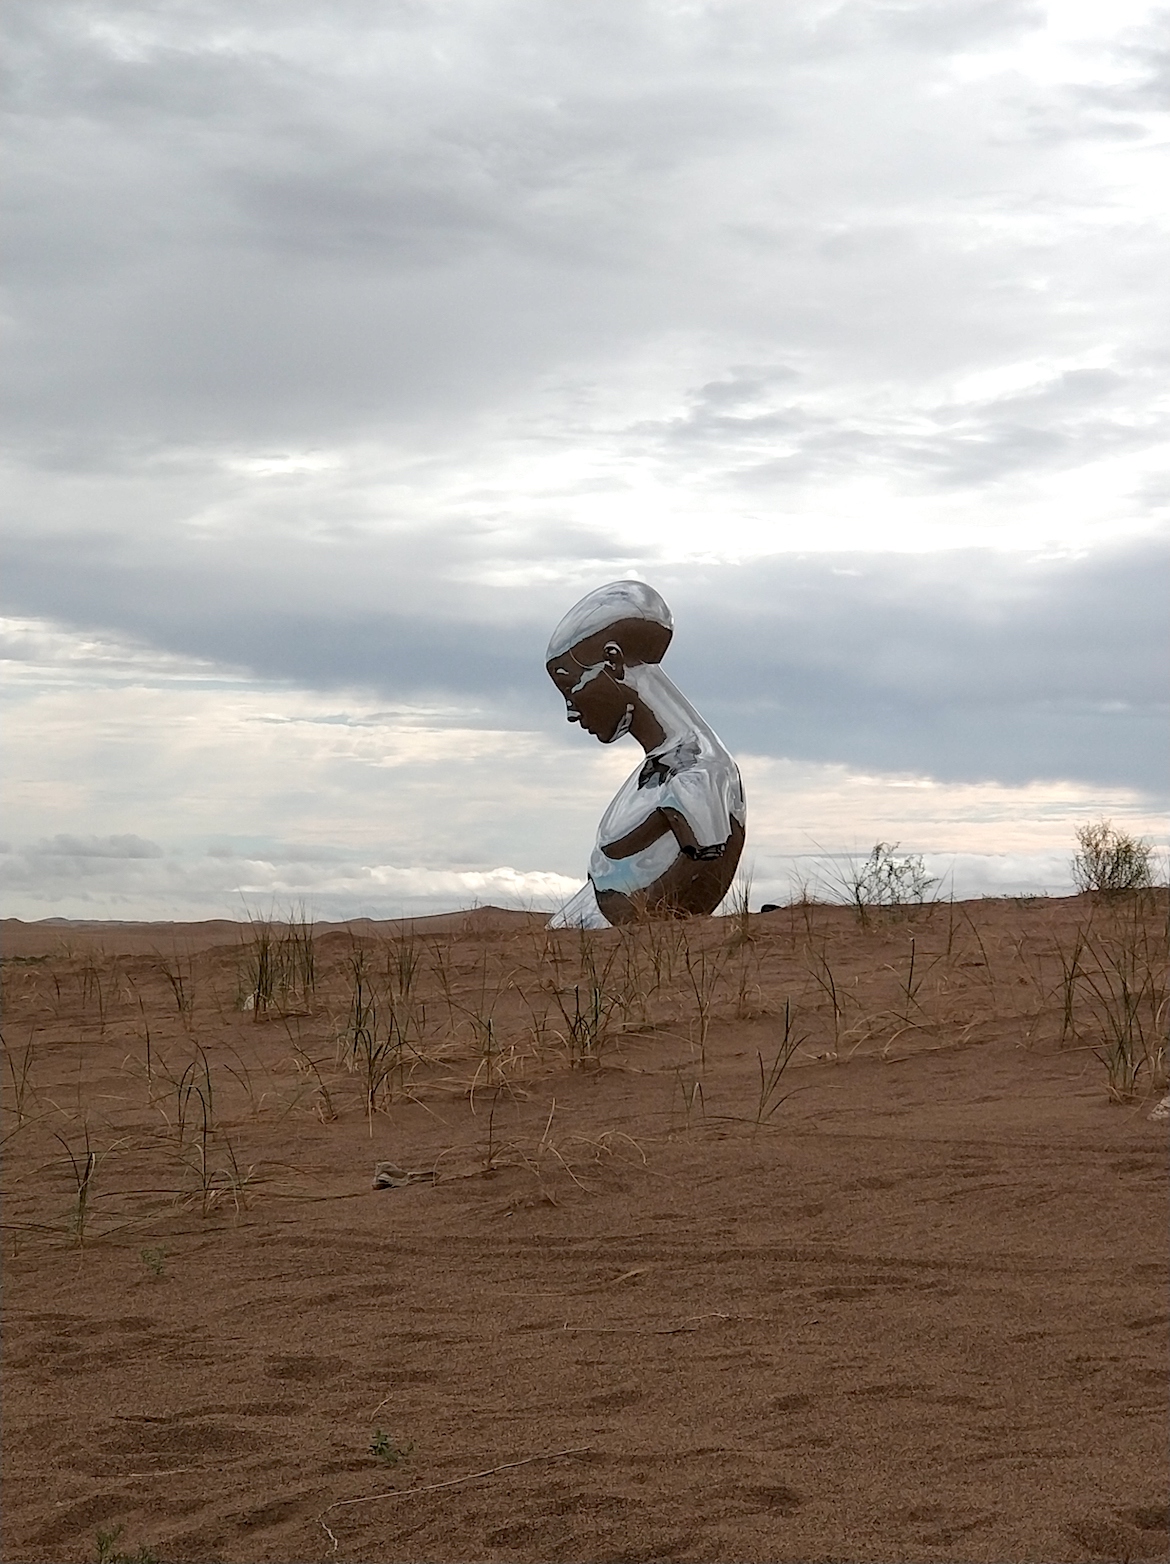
[547,582,746,929]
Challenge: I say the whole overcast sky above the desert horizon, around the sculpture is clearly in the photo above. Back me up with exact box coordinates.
[0,0,1170,917]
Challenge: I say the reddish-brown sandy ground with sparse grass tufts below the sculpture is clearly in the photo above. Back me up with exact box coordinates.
[2,896,1170,1564]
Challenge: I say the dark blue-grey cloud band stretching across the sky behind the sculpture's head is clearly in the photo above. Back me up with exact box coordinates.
[8,516,1170,793]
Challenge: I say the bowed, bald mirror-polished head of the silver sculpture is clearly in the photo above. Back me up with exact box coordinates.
[546,582,674,744]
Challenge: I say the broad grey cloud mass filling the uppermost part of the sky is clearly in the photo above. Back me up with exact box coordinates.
[9,0,1162,443]
